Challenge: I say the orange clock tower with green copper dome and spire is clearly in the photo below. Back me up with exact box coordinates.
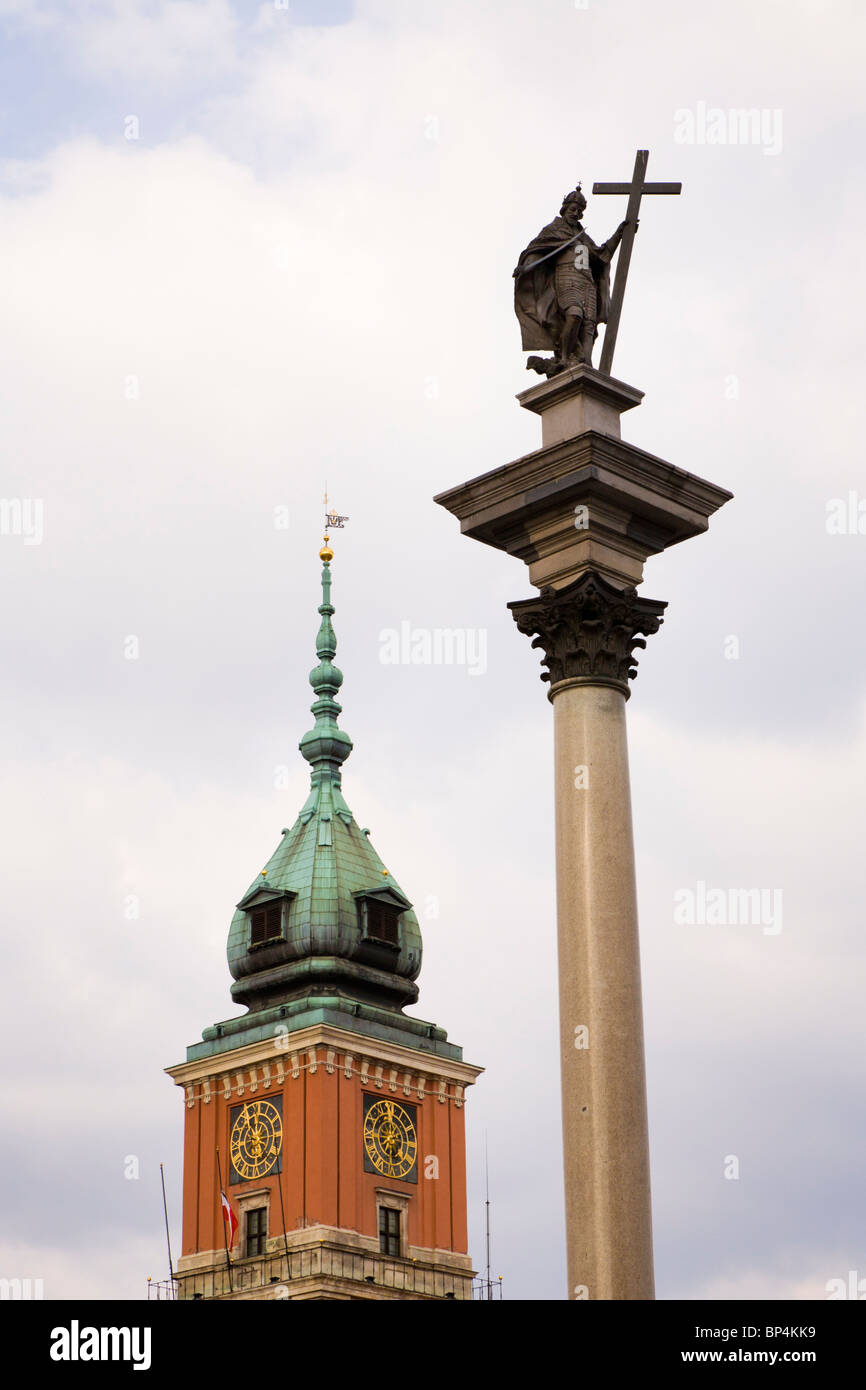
[168,537,481,1300]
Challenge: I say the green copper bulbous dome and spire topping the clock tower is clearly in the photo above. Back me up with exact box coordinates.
[183,548,460,1059]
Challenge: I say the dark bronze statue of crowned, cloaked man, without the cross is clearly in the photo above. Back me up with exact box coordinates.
[514,183,627,377]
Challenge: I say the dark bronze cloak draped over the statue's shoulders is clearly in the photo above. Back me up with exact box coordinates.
[514,217,613,350]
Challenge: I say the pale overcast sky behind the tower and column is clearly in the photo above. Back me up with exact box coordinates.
[0,0,866,1298]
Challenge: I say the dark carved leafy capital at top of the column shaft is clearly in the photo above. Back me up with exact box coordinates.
[509,570,667,699]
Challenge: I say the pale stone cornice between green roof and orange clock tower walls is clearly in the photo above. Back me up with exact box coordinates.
[165,1024,484,1108]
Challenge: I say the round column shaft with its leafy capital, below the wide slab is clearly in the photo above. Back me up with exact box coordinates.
[509,571,666,1300]
